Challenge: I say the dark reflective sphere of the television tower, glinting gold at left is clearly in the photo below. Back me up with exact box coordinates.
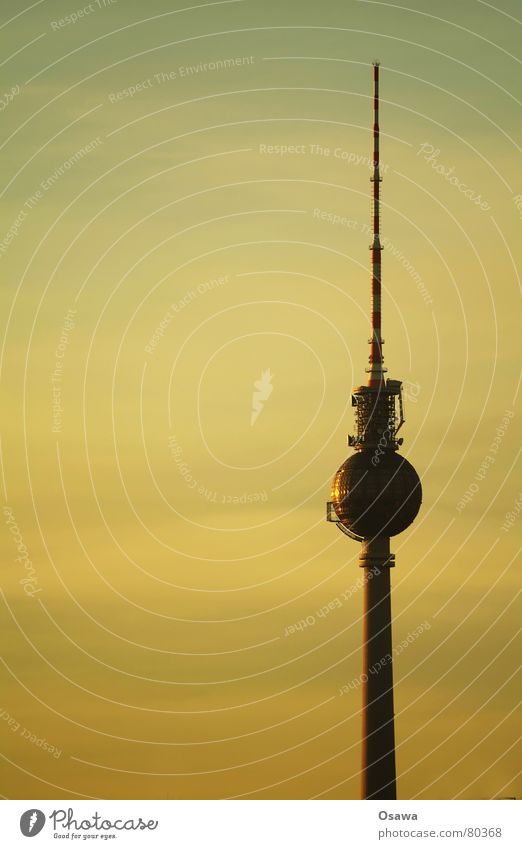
[332,451,422,539]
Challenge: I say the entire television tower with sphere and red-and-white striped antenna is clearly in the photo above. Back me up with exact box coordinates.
[327,62,422,799]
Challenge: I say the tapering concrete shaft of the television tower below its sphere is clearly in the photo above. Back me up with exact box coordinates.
[361,537,397,799]
